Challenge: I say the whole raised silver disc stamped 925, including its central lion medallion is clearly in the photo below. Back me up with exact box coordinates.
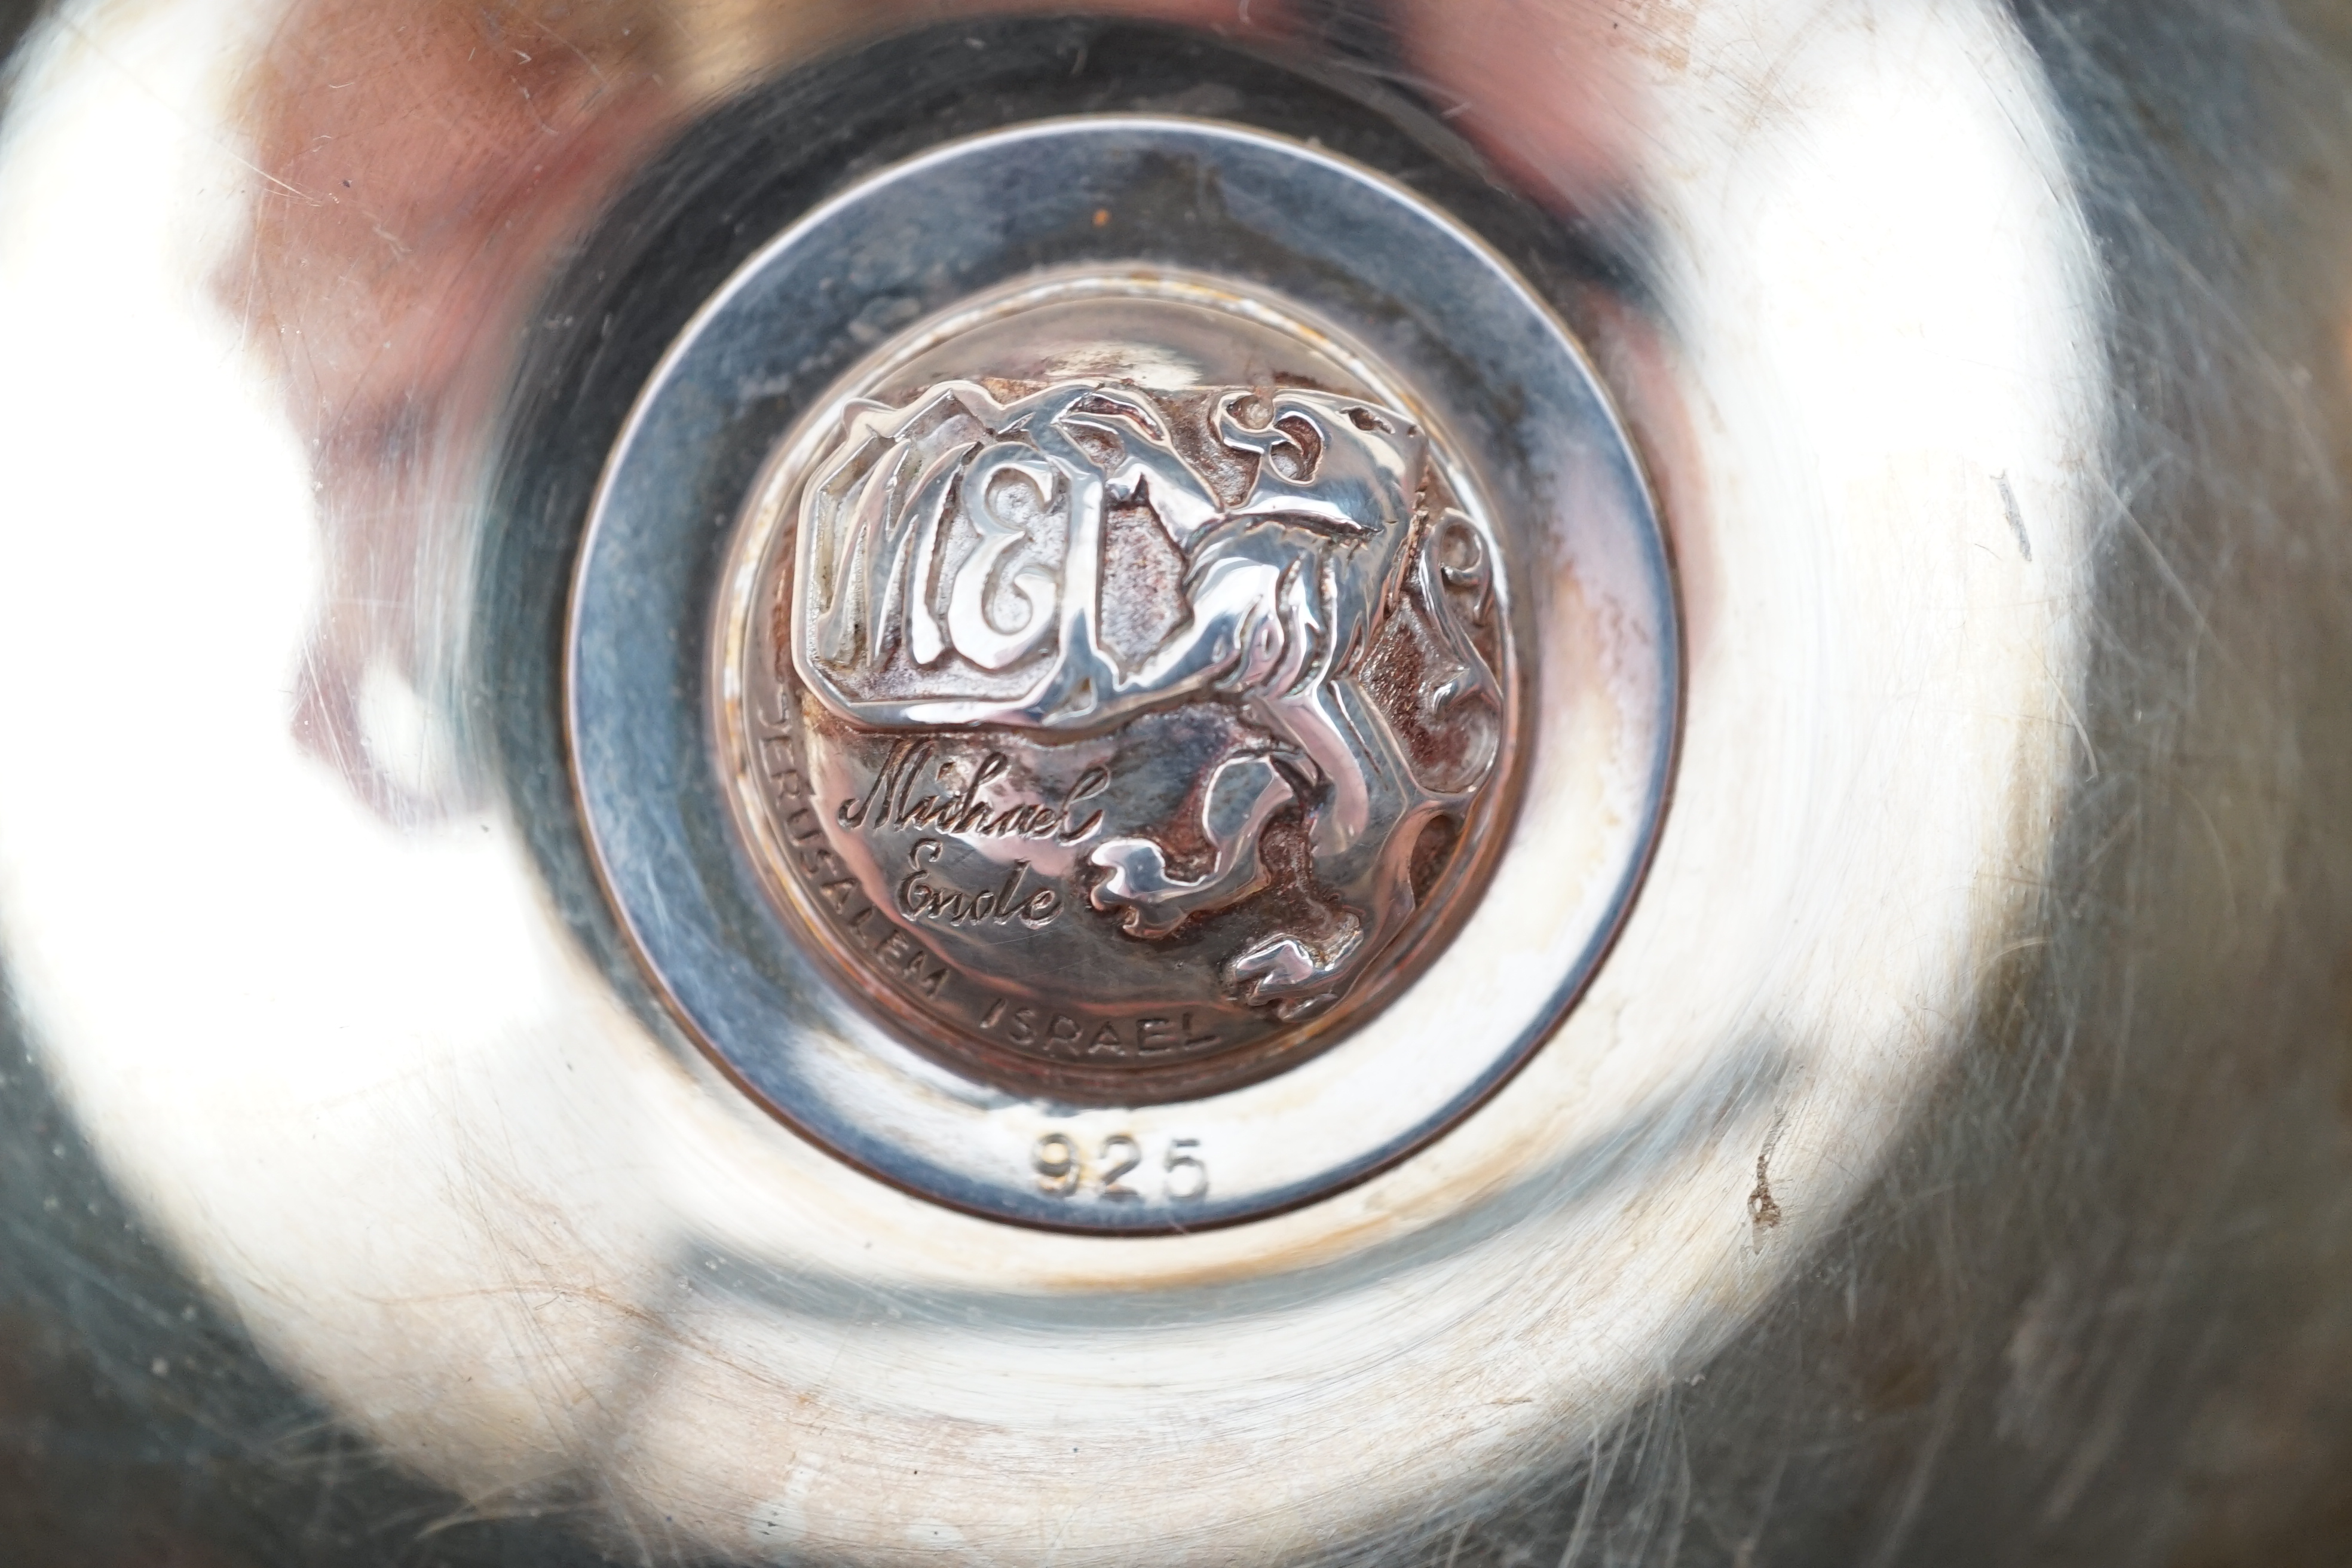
[571,118,1677,1232]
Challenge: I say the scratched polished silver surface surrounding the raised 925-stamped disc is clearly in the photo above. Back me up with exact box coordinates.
[0,0,2352,1568]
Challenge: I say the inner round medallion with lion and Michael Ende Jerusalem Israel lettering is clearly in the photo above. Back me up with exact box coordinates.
[719,275,1517,1102]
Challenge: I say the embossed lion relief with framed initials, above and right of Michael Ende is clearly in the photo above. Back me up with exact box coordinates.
[788,381,1505,1018]
